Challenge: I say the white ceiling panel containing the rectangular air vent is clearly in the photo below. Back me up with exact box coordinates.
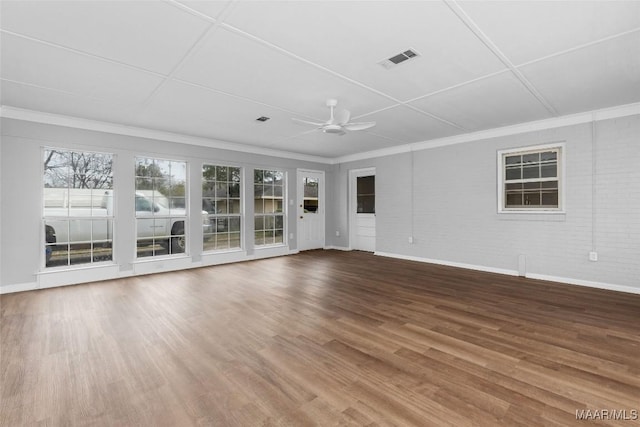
[225,1,504,100]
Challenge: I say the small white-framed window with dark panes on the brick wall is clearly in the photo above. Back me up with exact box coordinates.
[498,146,562,212]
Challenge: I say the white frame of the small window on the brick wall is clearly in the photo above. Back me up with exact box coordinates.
[496,142,566,214]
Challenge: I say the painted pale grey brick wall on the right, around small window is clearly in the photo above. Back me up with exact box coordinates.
[332,115,640,292]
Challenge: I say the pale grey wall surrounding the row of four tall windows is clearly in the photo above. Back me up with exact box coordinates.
[0,118,333,292]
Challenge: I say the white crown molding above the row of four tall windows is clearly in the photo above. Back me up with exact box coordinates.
[0,105,334,164]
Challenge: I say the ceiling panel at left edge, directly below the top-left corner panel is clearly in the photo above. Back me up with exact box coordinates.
[0,34,162,104]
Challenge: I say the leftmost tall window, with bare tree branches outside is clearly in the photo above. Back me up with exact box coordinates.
[43,148,113,267]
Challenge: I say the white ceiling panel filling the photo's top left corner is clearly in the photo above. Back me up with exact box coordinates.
[2,1,210,73]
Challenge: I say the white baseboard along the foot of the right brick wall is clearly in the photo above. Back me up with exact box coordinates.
[374,252,640,294]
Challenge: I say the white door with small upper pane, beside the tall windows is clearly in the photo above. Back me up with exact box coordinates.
[297,169,325,251]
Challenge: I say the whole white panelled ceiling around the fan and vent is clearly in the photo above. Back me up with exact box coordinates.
[0,0,640,158]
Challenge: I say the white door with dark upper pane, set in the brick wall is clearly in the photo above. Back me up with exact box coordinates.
[349,168,376,252]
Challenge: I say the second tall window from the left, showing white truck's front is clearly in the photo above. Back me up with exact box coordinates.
[135,157,187,258]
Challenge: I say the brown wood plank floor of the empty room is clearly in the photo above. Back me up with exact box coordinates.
[0,251,640,427]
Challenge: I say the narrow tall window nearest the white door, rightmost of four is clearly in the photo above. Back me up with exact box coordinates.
[253,169,285,246]
